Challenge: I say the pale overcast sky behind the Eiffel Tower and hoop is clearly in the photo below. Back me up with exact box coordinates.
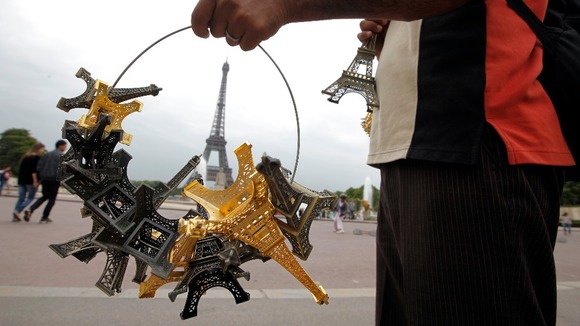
[0,0,379,191]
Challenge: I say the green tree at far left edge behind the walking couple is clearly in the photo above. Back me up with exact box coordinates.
[0,128,38,176]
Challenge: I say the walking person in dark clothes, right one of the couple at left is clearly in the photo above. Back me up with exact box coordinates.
[24,139,67,223]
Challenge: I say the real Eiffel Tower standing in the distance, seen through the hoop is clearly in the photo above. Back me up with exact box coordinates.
[203,61,234,187]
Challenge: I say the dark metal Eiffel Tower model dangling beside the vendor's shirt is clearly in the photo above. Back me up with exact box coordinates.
[322,34,379,134]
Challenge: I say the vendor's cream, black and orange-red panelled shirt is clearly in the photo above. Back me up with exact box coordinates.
[368,0,574,166]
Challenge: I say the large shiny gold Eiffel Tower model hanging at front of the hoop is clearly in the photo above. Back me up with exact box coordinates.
[183,143,328,304]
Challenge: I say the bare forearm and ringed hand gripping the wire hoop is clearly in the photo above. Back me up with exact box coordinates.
[191,0,470,50]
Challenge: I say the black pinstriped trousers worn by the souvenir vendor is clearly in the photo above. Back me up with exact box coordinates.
[376,127,563,326]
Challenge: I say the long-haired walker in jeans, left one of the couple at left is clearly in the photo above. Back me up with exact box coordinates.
[12,143,44,222]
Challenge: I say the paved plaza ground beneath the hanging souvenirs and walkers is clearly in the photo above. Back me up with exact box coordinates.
[0,191,580,326]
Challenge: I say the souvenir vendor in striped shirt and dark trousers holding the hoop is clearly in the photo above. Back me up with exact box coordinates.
[191,0,575,325]
